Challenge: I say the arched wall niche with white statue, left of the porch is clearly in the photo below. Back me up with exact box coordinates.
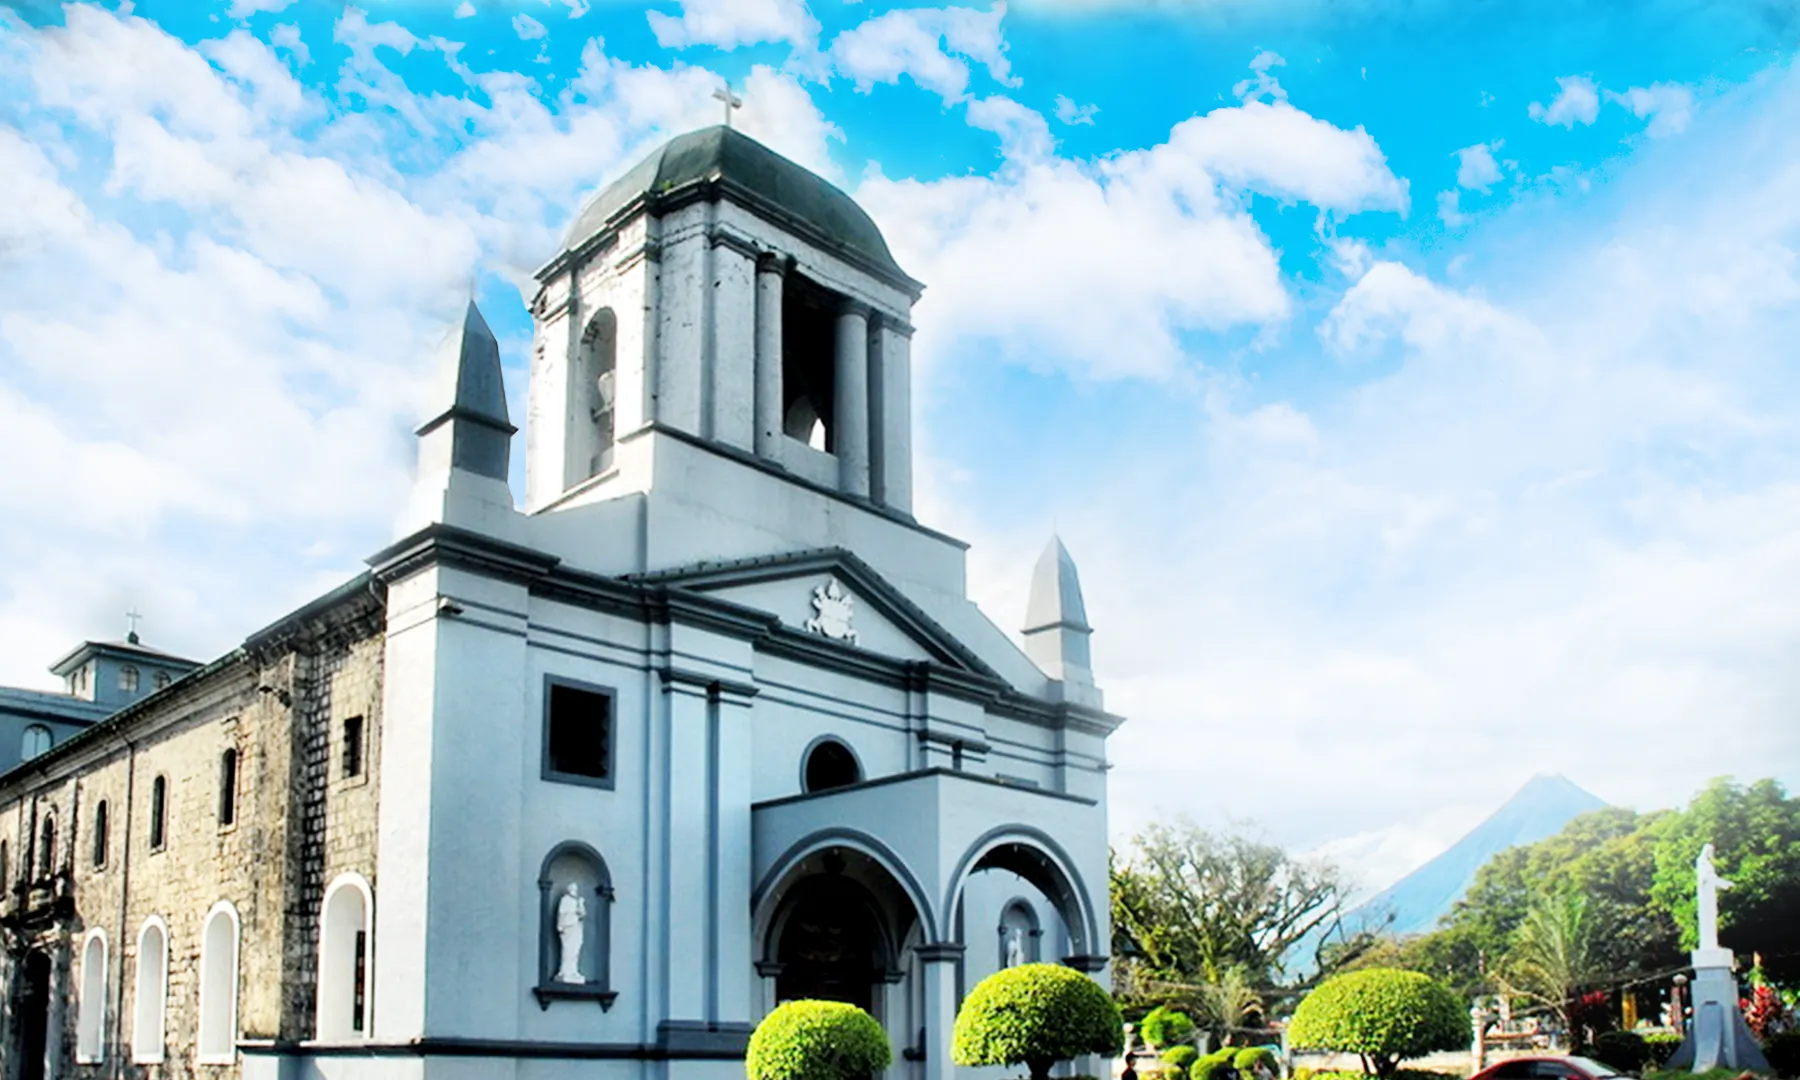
[531,841,617,1010]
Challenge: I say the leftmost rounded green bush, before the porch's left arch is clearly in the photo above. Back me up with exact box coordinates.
[743,1001,893,1080]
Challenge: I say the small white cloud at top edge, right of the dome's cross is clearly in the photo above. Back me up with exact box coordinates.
[828,2,1019,103]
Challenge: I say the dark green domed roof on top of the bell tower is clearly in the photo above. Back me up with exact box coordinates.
[563,124,918,292]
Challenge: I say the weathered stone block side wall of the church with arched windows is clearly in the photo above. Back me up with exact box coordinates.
[0,589,382,1080]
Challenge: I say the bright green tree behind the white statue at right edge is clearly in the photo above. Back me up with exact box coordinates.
[1651,779,1800,981]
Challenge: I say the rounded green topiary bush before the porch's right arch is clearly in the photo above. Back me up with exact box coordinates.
[950,963,1125,1080]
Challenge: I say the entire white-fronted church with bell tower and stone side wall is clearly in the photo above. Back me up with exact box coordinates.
[0,128,1120,1080]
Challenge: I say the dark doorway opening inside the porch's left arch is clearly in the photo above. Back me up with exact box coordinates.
[774,873,895,1013]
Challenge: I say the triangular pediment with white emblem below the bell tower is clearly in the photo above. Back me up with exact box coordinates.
[637,547,997,679]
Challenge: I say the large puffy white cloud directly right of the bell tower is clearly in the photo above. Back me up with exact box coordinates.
[857,99,1406,380]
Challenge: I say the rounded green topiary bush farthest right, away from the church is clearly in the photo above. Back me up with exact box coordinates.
[1287,968,1469,1076]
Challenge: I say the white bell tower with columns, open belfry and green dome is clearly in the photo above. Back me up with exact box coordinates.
[526,126,923,518]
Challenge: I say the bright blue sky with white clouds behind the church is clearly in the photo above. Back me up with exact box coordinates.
[0,0,1800,886]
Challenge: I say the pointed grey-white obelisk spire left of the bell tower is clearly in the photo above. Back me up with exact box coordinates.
[418,299,518,481]
